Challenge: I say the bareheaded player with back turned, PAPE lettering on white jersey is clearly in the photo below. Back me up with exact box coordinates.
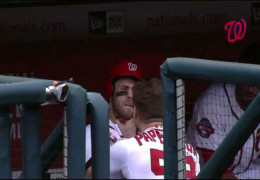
[110,78,200,179]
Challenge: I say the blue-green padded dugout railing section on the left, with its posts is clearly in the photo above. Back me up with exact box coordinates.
[0,76,109,179]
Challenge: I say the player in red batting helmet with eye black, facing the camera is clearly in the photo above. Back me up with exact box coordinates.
[86,60,141,178]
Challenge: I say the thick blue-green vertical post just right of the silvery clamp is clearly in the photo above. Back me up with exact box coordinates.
[66,84,87,179]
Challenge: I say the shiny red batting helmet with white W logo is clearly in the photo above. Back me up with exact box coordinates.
[106,60,141,100]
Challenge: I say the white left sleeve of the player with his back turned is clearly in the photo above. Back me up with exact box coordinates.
[110,140,128,179]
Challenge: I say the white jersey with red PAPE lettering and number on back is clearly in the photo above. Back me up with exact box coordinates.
[110,126,200,179]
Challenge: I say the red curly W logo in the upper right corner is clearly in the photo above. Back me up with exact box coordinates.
[225,19,246,43]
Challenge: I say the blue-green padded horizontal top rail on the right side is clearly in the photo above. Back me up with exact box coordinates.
[165,57,260,85]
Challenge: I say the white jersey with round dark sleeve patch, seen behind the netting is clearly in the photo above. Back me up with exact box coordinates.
[187,84,260,179]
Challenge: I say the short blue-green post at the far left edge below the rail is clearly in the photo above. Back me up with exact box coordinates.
[0,105,12,179]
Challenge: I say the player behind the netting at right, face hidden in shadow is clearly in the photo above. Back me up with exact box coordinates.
[187,44,260,179]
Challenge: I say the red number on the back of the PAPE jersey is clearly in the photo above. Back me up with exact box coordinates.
[150,149,196,179]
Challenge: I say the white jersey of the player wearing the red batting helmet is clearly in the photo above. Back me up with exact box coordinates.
[86,120,122,165]
